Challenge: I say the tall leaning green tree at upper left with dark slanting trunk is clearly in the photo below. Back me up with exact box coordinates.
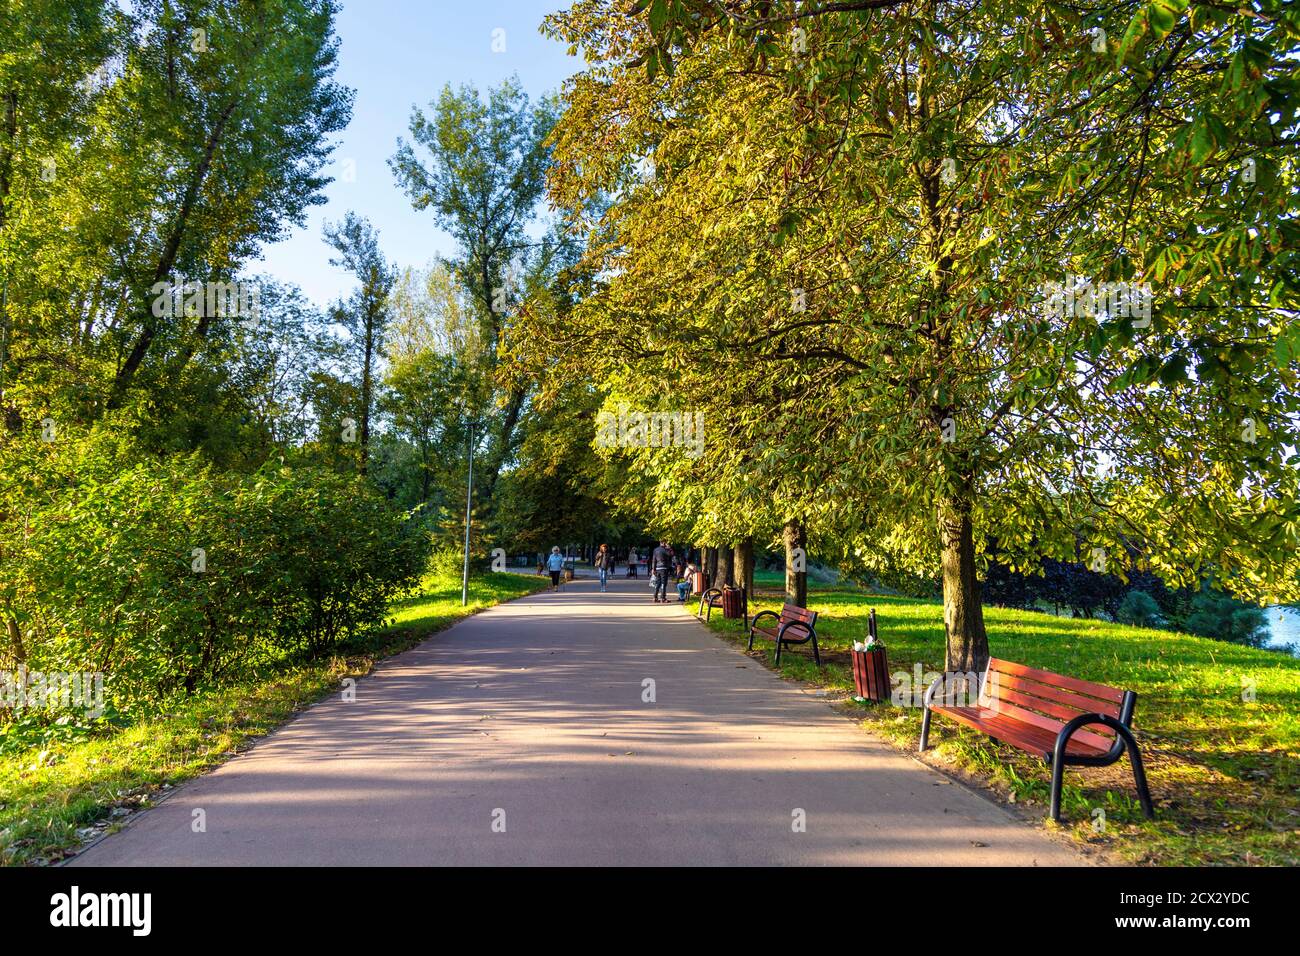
[104,0,351,406]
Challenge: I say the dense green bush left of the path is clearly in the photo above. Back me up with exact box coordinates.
[0,426,425,717]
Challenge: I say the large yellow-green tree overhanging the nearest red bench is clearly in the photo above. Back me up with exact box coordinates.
[535,0,1300,671]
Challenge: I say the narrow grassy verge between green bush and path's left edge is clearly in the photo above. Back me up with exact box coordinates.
[0,574,541,865]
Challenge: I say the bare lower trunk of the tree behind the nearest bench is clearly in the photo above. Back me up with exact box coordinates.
[937,498,988,674]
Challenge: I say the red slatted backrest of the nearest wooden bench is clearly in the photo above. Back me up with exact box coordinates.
[980,657,1135,749]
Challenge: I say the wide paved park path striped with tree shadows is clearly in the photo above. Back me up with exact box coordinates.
[69,578,1082,866]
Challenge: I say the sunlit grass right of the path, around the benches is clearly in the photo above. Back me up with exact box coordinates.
[712,588,1300,866]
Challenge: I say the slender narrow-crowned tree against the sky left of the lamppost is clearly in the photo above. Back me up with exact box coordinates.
[325,212,397,475]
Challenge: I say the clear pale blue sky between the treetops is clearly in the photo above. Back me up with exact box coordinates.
[247,0,581,306]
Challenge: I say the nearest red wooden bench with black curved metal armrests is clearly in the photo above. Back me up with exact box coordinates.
[920,658,1156,822]
